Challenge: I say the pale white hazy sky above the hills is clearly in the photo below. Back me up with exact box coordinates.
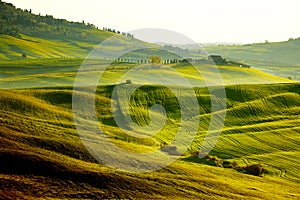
[4,0,300,43]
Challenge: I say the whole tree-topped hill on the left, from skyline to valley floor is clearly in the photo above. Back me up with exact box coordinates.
[0,0,202,60]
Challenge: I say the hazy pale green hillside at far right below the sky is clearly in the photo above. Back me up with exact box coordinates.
[206,39,300,80]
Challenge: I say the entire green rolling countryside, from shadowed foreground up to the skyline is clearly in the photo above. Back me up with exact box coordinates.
[0,0,300,200]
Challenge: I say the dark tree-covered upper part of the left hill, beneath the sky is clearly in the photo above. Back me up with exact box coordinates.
[0,1,124,44]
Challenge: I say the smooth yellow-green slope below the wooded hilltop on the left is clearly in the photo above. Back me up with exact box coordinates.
[0,30,161,61]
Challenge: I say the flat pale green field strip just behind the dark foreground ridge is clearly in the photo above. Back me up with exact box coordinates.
[0,58,291,88]
